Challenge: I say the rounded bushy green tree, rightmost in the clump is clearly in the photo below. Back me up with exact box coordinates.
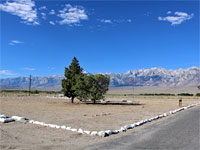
[88,74,110,104]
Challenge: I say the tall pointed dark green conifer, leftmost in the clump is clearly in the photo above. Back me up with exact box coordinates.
[62,57,83,103]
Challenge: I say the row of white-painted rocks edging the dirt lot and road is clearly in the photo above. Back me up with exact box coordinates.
[0,102,200,137]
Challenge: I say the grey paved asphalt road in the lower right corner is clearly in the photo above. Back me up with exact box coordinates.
[86,106,200,150]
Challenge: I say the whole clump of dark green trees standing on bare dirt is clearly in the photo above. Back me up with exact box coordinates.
[62,57,110,103]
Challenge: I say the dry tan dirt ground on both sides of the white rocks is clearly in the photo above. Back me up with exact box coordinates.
[0,96,200,150]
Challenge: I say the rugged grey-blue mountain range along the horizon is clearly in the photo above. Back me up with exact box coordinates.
[0,67,200,89]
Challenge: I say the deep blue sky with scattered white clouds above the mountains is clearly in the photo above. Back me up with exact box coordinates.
[0,0,199,78]
